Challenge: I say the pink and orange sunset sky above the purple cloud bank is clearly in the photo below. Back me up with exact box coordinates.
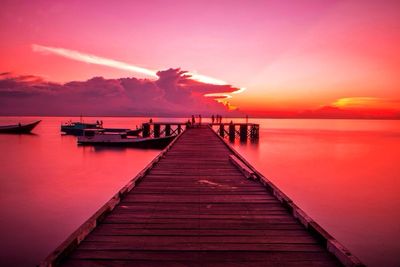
[0,0,400,116]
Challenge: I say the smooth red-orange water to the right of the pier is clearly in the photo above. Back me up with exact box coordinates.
[235,120,400,267]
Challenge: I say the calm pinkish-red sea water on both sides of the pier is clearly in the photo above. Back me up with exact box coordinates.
[0,117,400,266]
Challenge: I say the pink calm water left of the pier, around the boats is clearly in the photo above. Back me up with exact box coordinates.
[0,117,159,266]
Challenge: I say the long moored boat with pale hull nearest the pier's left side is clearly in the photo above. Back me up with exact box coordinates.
[78,129,176,148]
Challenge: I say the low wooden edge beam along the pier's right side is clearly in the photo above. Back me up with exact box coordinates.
[209,126,365,267]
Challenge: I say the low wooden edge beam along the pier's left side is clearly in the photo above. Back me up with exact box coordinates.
[39,129,186,267]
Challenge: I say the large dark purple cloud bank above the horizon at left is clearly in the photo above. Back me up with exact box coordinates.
[0,69,241,116]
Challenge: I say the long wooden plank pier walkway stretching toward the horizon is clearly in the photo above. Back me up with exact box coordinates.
[41,126,363,267]
